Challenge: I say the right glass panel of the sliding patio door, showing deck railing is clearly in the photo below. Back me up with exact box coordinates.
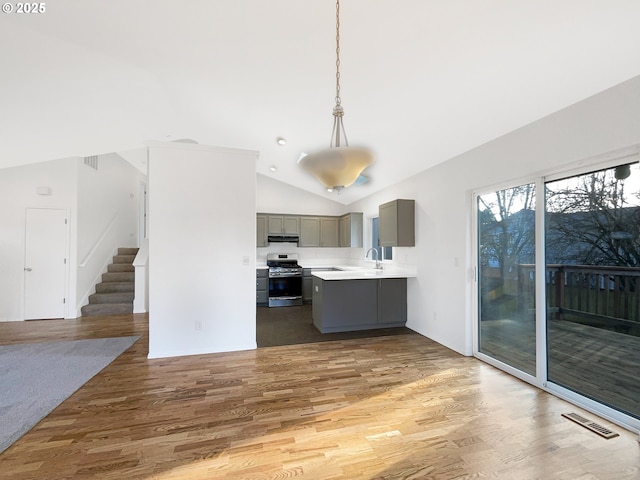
[545,164,640,418]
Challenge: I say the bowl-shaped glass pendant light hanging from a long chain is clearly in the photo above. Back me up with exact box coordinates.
[298,0,373,193]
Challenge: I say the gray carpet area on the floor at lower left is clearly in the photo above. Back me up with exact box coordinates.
[0,337,140,453]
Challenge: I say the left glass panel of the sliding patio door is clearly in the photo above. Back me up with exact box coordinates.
[477,184,536,375]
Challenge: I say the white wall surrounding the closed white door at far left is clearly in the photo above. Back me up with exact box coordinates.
[0,158,77,321]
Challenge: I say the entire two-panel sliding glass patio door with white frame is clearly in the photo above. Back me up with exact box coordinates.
[474,158,640,428]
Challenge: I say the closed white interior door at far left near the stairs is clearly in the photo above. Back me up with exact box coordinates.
[24,208,68,320]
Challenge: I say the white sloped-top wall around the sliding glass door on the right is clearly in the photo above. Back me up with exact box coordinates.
[349,77,640,355]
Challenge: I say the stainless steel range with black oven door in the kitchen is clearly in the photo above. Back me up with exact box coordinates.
[267,253,302,307]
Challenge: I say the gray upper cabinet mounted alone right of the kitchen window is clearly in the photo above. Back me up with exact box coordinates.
[378,200,416,247]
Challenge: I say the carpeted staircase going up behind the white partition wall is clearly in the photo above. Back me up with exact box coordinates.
[81,248,138,317]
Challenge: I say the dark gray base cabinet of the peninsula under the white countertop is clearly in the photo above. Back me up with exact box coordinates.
[312,277,407,333]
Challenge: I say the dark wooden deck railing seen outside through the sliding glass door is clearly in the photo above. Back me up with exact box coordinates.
[518,264,640,326]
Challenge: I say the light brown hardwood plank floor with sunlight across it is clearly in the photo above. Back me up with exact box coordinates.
[0,315,640,480]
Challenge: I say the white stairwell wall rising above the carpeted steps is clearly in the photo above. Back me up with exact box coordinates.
[75,153,146,316]
